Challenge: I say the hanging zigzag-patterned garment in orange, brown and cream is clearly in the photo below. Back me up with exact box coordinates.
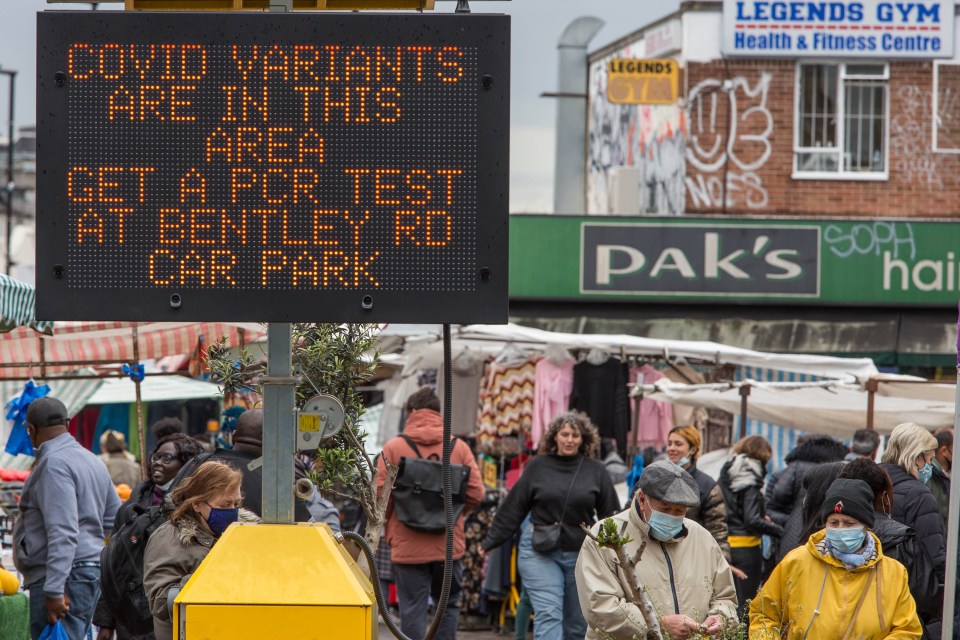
[477,360,536,455]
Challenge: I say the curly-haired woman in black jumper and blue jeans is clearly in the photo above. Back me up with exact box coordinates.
[481,411,620,640]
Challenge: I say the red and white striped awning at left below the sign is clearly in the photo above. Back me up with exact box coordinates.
[0,322,266,379]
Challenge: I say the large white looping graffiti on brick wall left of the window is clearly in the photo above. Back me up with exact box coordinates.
[685,73,774,209]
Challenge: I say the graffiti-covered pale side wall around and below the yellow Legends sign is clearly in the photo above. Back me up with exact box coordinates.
[587,56,686,214]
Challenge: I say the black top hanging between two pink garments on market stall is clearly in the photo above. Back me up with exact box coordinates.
[570,358,630,456]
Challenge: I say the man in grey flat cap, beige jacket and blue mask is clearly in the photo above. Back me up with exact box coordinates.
[576,460,737,640]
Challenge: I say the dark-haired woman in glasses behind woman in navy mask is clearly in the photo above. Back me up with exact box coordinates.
[93,433,203,640]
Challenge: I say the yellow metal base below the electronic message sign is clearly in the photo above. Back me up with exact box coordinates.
[173,524,378,640]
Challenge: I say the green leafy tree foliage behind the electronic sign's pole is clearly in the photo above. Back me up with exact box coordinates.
[207,323,380,517]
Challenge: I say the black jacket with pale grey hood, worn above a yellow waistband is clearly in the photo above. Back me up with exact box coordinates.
[720,454,783,538]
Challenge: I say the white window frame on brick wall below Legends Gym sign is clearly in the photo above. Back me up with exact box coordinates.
[790,60,890,182]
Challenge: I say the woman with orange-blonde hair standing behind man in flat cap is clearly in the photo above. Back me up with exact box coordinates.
[667,425,730,562]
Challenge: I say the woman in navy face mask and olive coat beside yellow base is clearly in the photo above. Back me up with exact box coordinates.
[143,460,258,640]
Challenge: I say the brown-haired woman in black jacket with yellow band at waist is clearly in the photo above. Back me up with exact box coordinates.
[719,436,783,616]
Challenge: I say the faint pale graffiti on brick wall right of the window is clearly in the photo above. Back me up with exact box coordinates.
[890,85,960,190]
